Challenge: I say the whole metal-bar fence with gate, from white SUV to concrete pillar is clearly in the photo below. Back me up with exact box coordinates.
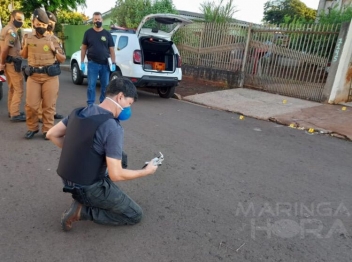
[178,23,340,101]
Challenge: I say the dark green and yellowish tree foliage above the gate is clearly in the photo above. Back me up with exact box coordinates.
[263,0,316,25]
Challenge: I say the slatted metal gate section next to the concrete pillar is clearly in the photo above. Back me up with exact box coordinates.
[244,25,339,101]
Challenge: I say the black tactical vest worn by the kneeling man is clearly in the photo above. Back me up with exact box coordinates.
[57,108,113,185]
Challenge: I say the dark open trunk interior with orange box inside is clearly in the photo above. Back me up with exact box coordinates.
[140,37,178,72]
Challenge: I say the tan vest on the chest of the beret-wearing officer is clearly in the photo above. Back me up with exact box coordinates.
[27,34,56,67]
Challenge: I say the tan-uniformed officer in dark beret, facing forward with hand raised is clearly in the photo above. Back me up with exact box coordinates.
[21,8,66,139]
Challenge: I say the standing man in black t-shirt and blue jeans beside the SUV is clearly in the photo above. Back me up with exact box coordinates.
[81,12,116,105]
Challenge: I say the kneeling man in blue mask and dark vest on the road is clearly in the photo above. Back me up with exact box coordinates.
[47,78,157,231]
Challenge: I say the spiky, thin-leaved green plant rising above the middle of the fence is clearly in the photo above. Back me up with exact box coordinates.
[200,0,237,23]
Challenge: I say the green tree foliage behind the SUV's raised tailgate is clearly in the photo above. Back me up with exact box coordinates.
[112,0,178,28]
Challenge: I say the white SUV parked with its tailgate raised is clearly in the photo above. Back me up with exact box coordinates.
[71,14,192,98]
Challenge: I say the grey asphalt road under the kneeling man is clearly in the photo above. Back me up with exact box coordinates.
[0,72,352,262]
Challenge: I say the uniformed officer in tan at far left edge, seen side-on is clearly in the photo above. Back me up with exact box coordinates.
[0,10,26,122]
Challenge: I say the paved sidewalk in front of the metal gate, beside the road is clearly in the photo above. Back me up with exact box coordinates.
[182,88,352,140]
